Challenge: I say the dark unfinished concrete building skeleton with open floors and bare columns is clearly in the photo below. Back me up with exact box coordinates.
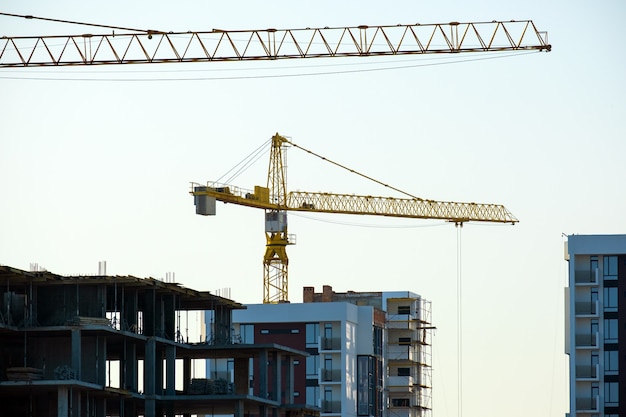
[0,266,319,417]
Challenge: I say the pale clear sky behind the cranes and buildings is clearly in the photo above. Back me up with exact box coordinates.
[0,0,626,417]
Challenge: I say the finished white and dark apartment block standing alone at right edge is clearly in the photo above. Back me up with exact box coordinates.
[565,235,626,417]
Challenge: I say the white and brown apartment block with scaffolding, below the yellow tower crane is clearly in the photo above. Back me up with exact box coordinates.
[227,286,433,417]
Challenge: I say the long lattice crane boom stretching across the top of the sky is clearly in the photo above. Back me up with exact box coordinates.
[0,16,551,68]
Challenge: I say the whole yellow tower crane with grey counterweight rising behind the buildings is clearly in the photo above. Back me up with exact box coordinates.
[190,133,518,304]
